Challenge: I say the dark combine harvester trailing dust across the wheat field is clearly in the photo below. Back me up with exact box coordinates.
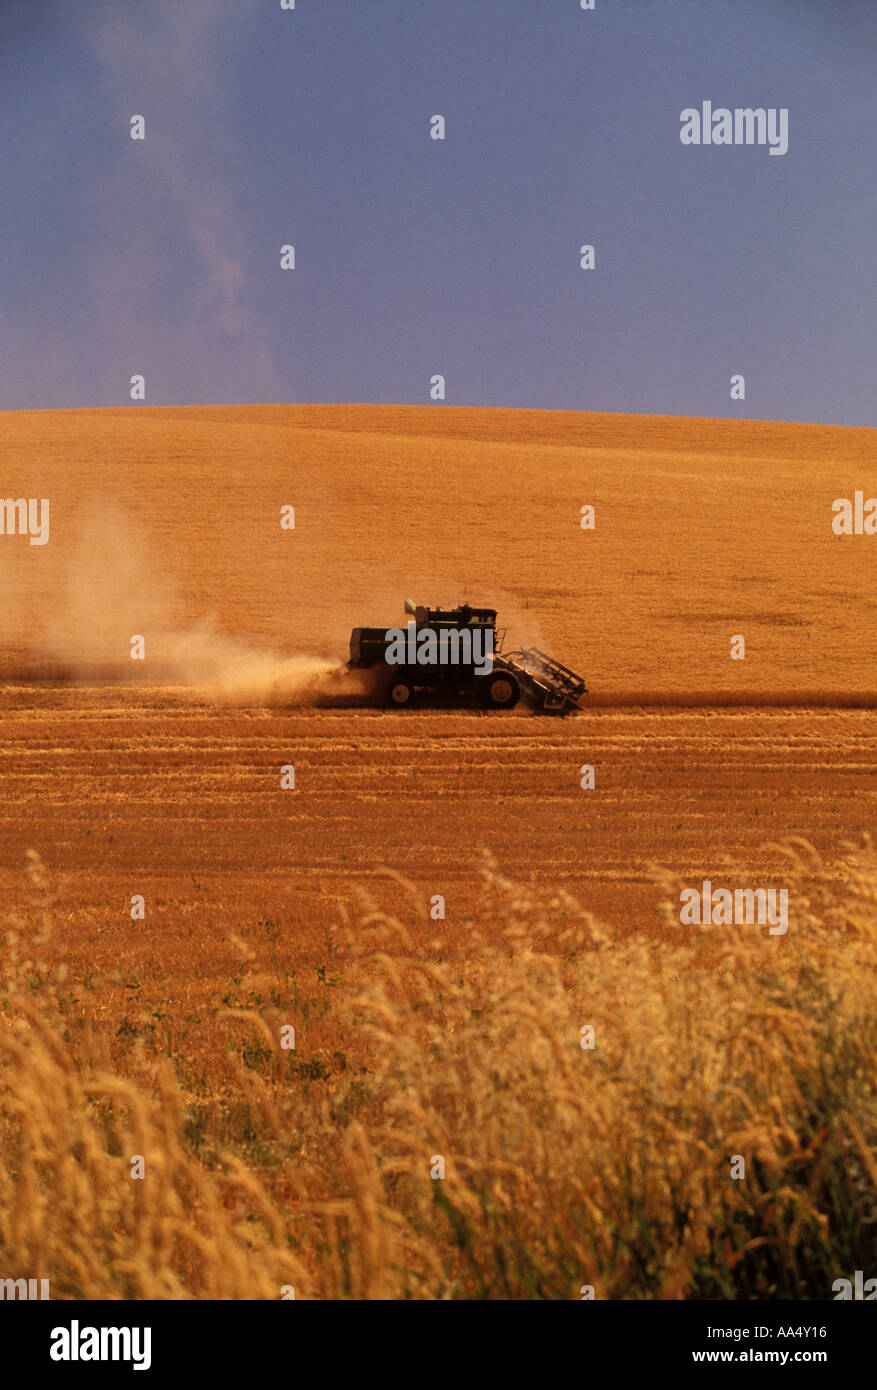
[347,599,588,714]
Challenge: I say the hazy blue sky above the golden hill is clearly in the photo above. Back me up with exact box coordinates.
[0,0,877,425]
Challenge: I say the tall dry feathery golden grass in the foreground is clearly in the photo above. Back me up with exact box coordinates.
[0,841,877,1298]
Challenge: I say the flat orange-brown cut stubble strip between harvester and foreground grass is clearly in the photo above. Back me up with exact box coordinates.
[0,689,877,961]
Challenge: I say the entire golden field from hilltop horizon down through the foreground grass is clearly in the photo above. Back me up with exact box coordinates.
[0,406,877,1298]
